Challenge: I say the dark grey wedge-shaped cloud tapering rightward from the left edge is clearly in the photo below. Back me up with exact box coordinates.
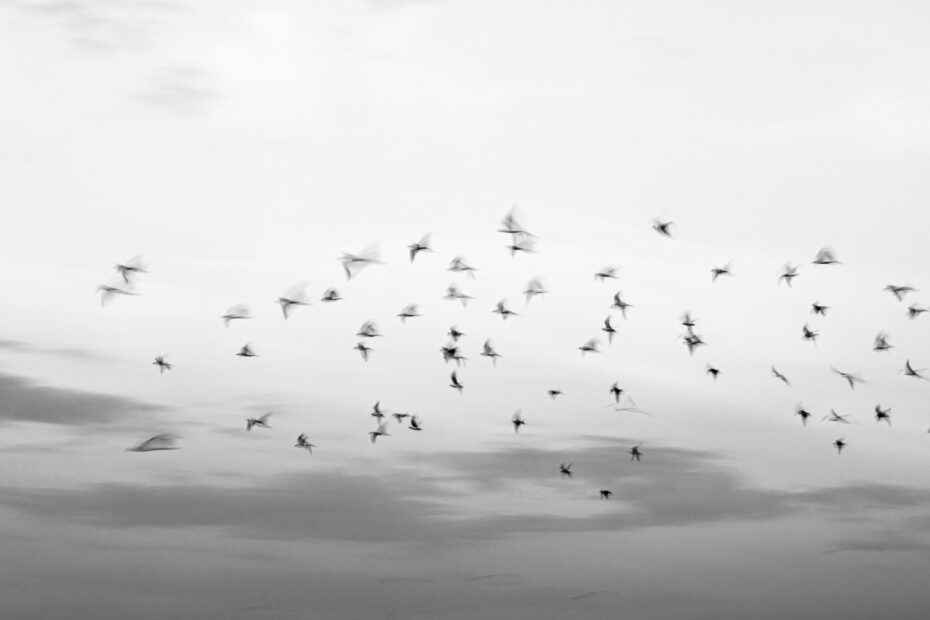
[0,374,164,426]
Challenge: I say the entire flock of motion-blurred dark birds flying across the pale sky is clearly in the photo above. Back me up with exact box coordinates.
[97,210,930,499]
